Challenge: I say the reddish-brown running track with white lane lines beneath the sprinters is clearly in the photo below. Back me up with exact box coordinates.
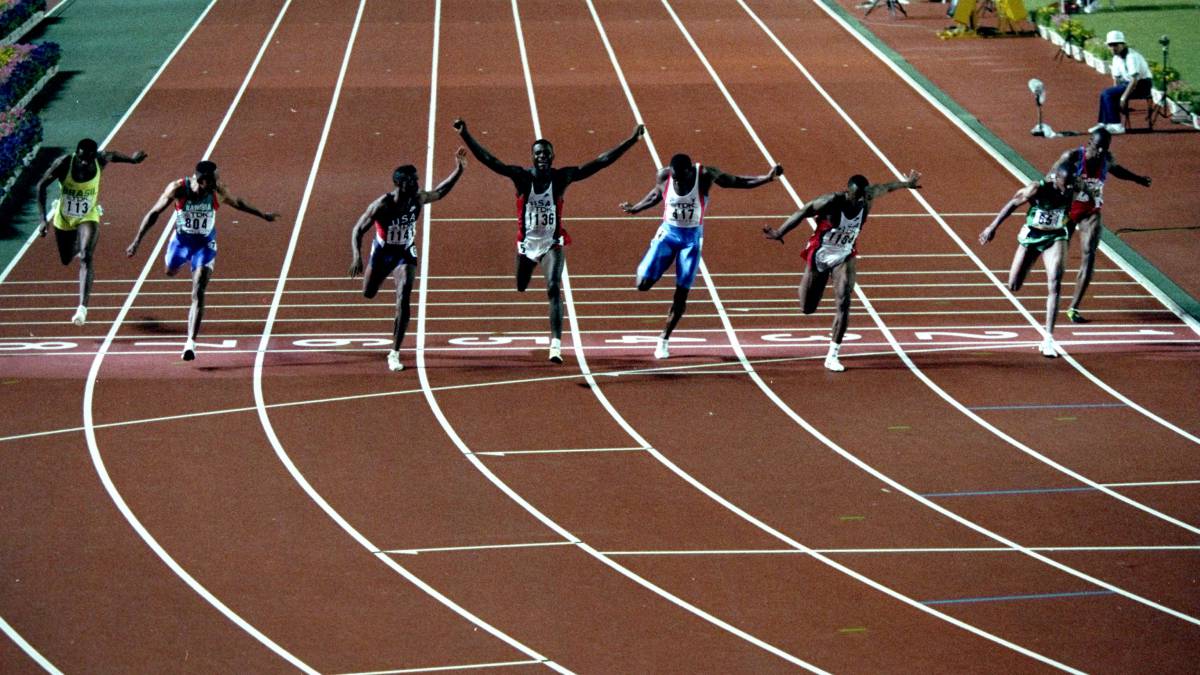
[0,0,1200,673]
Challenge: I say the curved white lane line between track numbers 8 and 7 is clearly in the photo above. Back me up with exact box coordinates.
[83,0,317,674]
